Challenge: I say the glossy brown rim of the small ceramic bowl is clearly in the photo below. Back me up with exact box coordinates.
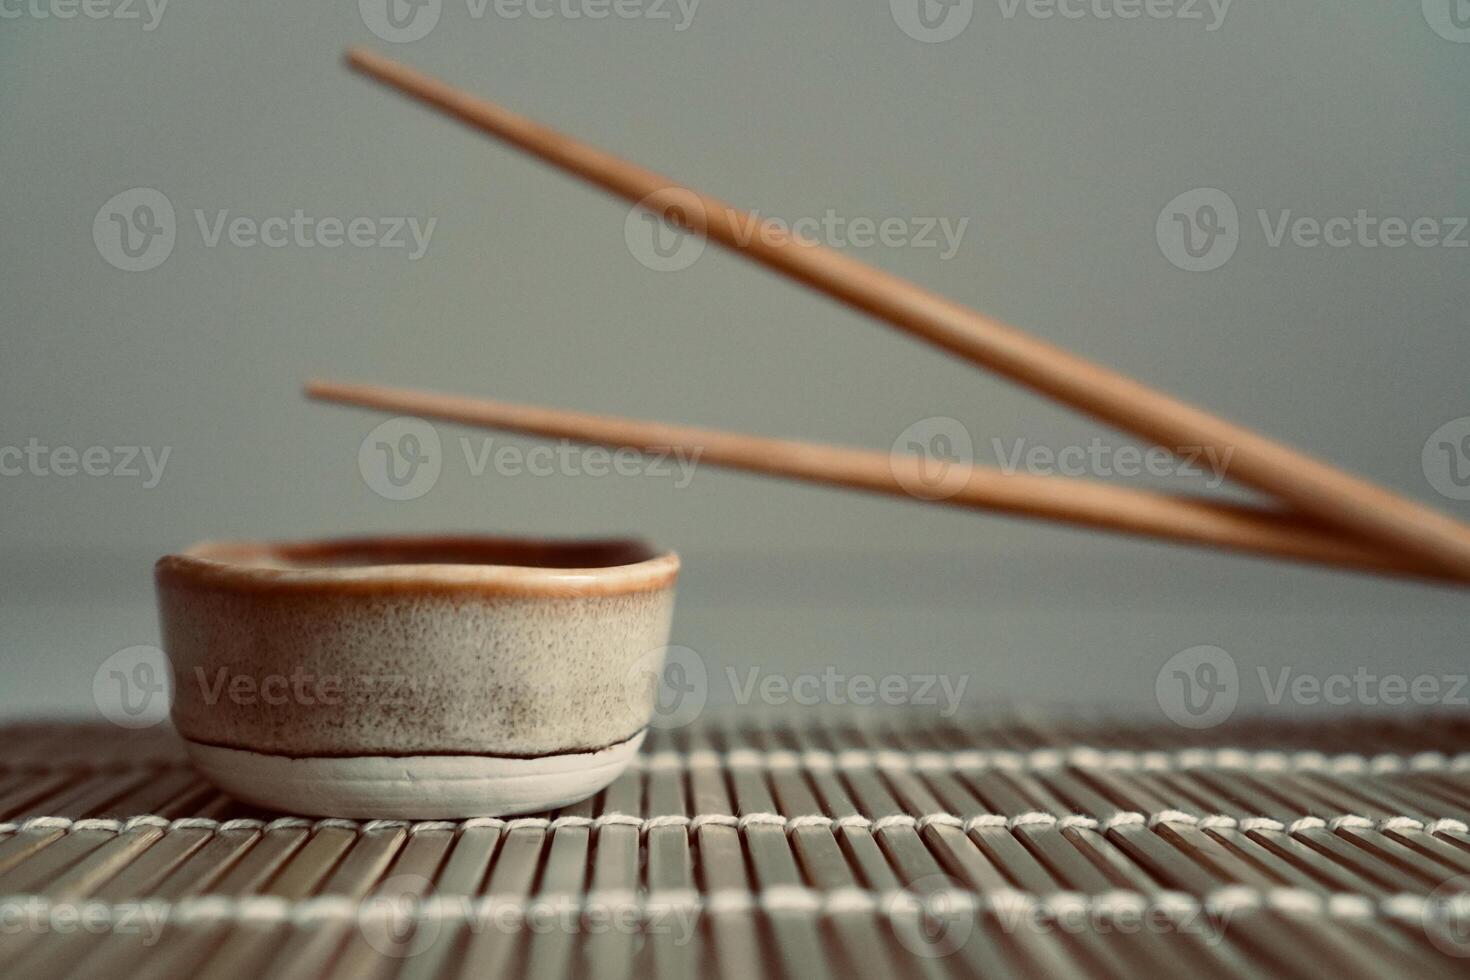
[153,535,679,598]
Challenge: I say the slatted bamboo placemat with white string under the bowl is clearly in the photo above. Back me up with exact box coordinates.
[0,710,1470,980]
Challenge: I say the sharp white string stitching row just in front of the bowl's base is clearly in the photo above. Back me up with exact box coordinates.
[0,810,1470,835]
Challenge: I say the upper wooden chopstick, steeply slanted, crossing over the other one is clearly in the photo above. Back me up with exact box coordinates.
[338,48,1470,576]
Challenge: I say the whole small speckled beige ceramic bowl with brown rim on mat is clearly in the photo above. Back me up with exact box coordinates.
[154,536,679,820]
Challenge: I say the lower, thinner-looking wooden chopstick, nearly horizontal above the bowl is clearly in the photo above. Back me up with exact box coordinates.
[306,381,1463,582]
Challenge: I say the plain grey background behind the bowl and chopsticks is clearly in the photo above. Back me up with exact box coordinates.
[0,0,1470,728]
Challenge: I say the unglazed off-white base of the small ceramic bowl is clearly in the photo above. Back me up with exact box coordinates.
[185,732,644,820]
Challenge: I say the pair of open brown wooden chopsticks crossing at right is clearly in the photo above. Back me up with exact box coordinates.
[307,48,1470,583]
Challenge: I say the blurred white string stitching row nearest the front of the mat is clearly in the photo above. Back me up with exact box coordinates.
[0,884,1470,930]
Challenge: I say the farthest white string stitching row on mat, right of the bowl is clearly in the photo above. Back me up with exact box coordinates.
[632,746,1470,774]
